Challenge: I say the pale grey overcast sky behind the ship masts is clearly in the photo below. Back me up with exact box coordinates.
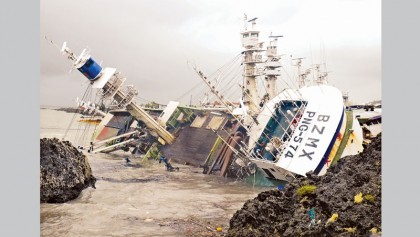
[40,0,381,106]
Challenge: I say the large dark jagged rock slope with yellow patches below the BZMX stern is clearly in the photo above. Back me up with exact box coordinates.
[227,135,382,237]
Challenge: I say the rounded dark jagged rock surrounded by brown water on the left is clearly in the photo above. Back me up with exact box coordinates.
[40,138,96,203]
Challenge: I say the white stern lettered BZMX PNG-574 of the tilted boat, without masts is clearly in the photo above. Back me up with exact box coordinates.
[248,85,363,180]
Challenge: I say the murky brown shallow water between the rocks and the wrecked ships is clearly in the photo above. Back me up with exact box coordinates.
[40,109,266,236]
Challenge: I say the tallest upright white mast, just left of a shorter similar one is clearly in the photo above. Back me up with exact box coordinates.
[241,14,264,116]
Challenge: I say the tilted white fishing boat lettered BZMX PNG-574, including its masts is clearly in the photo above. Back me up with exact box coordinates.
[198,15,363,181]
